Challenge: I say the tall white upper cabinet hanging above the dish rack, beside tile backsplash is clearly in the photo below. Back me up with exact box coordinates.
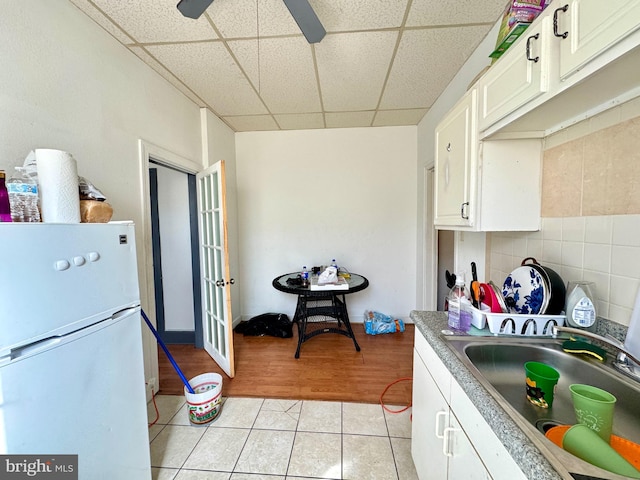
[434,88,542,231]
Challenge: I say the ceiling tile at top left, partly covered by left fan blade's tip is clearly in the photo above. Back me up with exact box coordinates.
[92,0,218,43]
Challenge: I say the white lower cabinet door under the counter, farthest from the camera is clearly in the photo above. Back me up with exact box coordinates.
[411,348,449,479]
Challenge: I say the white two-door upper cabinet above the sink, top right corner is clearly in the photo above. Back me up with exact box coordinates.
[477,0,640,139]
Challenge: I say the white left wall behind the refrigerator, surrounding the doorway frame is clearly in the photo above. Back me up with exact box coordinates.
[0,0,202,386]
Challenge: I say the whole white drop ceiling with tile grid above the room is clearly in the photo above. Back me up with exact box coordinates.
[70,0,506,132]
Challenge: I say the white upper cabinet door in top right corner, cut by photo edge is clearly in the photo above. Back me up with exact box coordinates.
[552,0,640,80]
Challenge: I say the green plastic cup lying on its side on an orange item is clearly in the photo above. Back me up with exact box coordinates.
[562,423,640,478]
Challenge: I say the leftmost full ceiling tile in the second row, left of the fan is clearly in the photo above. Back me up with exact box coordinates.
[147,42,267,116]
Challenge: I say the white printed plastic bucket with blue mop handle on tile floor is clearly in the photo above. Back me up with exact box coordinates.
[184,373,222,425]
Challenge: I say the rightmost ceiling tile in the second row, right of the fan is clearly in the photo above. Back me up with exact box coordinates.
[380,26,490,110]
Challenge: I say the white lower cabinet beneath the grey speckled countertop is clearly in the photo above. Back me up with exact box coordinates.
[411,330,526,480]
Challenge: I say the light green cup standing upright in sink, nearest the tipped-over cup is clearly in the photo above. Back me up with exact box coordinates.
[569,383,616,443]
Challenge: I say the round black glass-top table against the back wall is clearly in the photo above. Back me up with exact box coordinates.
[272,273,369,358]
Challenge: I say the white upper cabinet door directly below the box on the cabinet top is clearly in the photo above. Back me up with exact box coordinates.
[478,17,551,131]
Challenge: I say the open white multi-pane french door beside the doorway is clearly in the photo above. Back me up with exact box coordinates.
[196,160,235,377]
